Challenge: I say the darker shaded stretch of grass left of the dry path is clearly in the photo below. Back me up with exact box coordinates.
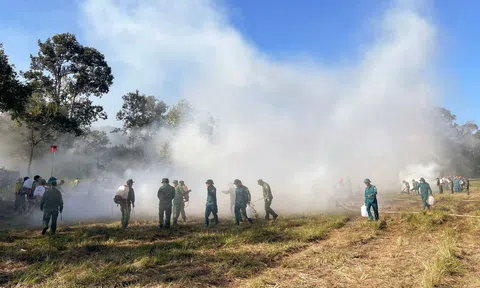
[0,217,347,286]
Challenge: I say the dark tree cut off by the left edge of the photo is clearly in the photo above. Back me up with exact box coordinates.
[0,43,30,113]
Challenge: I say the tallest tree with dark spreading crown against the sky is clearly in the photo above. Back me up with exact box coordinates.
[24,33,114,129]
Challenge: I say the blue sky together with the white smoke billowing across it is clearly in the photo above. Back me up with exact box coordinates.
[0,0,472,209]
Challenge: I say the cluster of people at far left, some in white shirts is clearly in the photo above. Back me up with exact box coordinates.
[15,175,63,235]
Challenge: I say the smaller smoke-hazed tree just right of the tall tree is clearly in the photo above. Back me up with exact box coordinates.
[112,90,167,145]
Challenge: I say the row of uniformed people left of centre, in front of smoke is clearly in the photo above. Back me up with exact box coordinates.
[114,178,278,229]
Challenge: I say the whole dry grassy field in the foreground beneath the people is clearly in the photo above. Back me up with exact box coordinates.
[0,182,480,287]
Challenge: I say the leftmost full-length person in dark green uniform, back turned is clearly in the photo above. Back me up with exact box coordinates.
[40,177,63,235]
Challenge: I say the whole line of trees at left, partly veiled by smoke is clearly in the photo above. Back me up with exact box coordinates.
[0,33,215,177]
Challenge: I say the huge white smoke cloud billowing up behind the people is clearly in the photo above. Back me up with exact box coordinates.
[73,0,444,217]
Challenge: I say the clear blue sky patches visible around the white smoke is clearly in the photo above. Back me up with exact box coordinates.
[0,0,480,122]
